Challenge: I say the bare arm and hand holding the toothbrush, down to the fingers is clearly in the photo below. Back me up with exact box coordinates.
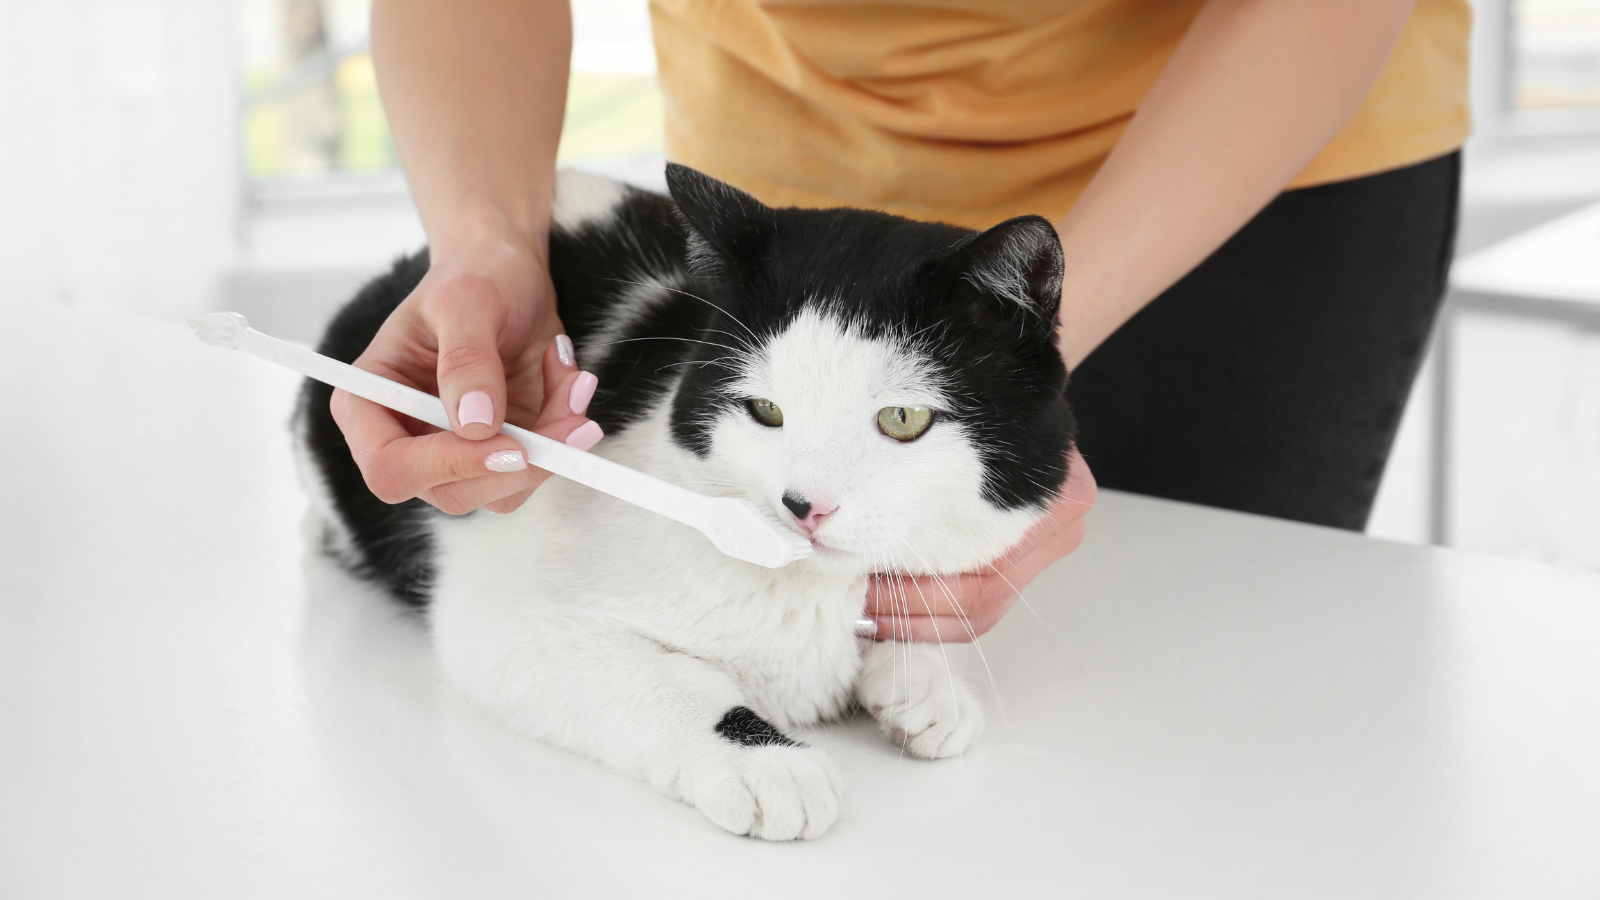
[333,0,594,512]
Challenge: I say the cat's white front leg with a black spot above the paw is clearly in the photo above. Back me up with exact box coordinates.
[442,629,843,841]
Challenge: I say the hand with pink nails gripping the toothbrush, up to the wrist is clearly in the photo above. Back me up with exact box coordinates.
[331,242,600,514]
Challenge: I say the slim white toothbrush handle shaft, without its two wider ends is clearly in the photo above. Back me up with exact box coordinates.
[234,328,709,527]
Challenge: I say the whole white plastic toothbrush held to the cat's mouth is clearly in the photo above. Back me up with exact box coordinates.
[189,312,811,569]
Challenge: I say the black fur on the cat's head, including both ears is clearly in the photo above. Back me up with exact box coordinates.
[667,165,1075,509]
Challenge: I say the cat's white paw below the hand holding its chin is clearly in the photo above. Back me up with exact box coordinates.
[856,641,984,759]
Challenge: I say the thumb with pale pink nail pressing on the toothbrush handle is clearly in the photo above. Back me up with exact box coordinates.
[435,302,506,440]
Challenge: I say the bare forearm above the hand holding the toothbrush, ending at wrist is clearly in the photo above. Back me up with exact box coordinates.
[373,0,573,258]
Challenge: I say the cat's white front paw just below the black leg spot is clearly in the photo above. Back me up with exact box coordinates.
[693,746,845,841]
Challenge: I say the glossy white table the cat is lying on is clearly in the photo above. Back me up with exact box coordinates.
[0,307,1600,900]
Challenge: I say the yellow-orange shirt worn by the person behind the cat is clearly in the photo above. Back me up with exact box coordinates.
[651,0,1470,227]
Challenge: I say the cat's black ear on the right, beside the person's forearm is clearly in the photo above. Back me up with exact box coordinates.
[950,216,1066,328]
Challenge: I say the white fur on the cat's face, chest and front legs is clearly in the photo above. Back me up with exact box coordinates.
[308,176,1038,839]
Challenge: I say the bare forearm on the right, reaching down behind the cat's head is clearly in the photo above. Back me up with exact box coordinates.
[1058,0,1413,367]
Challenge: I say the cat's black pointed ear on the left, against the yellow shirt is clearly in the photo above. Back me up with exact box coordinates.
[667,163,773,274]
